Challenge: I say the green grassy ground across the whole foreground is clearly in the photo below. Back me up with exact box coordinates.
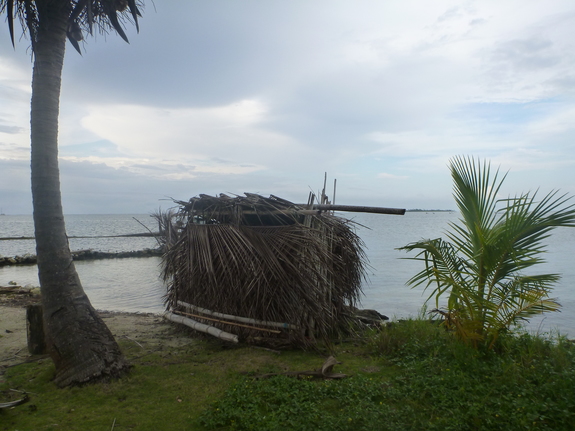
[0,320,575,431]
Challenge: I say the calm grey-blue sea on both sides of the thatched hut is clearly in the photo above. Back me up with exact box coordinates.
[0,211,575,338]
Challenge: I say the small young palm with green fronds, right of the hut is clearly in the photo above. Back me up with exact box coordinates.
[400,157,575,349]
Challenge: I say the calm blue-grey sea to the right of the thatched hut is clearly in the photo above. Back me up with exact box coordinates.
[353,211,575,337]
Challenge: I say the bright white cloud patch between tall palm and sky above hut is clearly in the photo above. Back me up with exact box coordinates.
[76,100,316,174]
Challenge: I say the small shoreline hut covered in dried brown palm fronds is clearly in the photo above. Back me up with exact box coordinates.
[157,193,366,344]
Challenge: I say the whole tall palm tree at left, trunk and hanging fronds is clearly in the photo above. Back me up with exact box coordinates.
[0,0,139,386]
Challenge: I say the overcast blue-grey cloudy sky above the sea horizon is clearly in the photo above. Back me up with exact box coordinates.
[0,0,575,214]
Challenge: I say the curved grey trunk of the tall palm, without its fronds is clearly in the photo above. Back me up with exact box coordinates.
[31,1,128,386]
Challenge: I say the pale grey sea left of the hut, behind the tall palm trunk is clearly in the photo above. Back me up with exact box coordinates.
[0,214,165,313]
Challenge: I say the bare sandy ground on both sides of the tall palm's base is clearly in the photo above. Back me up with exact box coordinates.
[0,294,192,381]
